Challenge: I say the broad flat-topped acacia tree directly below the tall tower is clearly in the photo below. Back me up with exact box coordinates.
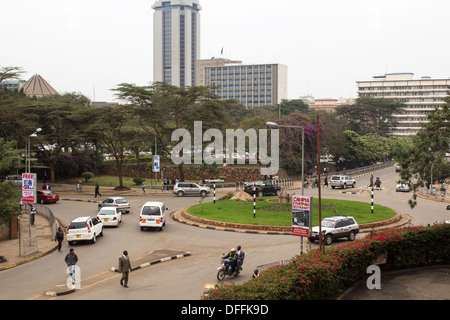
[114,82,229,181]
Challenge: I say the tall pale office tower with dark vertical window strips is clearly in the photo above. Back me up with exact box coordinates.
[152,0,201,87]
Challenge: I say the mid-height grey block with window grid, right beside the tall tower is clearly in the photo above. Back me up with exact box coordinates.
[196,59,287,109]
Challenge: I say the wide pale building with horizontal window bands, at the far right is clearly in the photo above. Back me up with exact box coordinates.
[356,73,450,136]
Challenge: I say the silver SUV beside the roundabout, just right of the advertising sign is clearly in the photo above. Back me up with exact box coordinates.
[308,216,359,245]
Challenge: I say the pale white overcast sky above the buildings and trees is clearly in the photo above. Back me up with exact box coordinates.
[0,0,450,101]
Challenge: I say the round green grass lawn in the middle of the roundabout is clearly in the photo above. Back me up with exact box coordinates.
[188,197,395,226]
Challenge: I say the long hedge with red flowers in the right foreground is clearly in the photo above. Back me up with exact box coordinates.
[204,224,450,300]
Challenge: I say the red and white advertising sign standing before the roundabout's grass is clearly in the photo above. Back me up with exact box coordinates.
[292,196,313,238]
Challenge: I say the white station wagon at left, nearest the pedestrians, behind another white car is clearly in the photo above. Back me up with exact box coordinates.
[67,217,103,245]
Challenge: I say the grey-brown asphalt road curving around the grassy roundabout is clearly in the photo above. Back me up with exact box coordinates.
[0,168,450,300]
